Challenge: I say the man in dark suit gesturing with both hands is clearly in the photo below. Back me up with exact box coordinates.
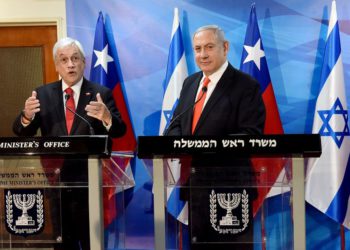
[13,38,126,250]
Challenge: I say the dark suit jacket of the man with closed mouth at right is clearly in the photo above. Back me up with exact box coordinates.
[167,64,265,136]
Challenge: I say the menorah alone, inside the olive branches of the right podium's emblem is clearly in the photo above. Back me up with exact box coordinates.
[217,193,241,226]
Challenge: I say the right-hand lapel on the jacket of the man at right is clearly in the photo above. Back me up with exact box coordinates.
[194,64,233,134]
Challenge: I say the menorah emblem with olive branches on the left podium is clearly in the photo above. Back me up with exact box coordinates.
[4,189,44,237]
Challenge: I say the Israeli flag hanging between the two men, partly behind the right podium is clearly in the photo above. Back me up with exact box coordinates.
[159,8,188,224]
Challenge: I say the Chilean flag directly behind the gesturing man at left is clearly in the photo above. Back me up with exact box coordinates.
[90,12,136,226]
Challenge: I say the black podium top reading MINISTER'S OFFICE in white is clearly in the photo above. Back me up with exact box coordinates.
[0,135,111,156]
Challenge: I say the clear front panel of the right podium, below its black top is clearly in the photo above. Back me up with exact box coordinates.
[163,156,293,249]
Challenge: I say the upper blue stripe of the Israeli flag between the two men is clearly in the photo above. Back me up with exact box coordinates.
[164,25,185,89]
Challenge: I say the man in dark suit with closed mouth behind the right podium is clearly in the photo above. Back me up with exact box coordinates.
[166,25,265,250]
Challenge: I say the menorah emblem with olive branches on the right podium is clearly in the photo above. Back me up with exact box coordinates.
[209,189,249,234]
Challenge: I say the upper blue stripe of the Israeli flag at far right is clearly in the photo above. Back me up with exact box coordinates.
[321,21,341,89]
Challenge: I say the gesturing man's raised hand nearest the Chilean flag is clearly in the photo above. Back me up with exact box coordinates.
[85,93,112,125]
